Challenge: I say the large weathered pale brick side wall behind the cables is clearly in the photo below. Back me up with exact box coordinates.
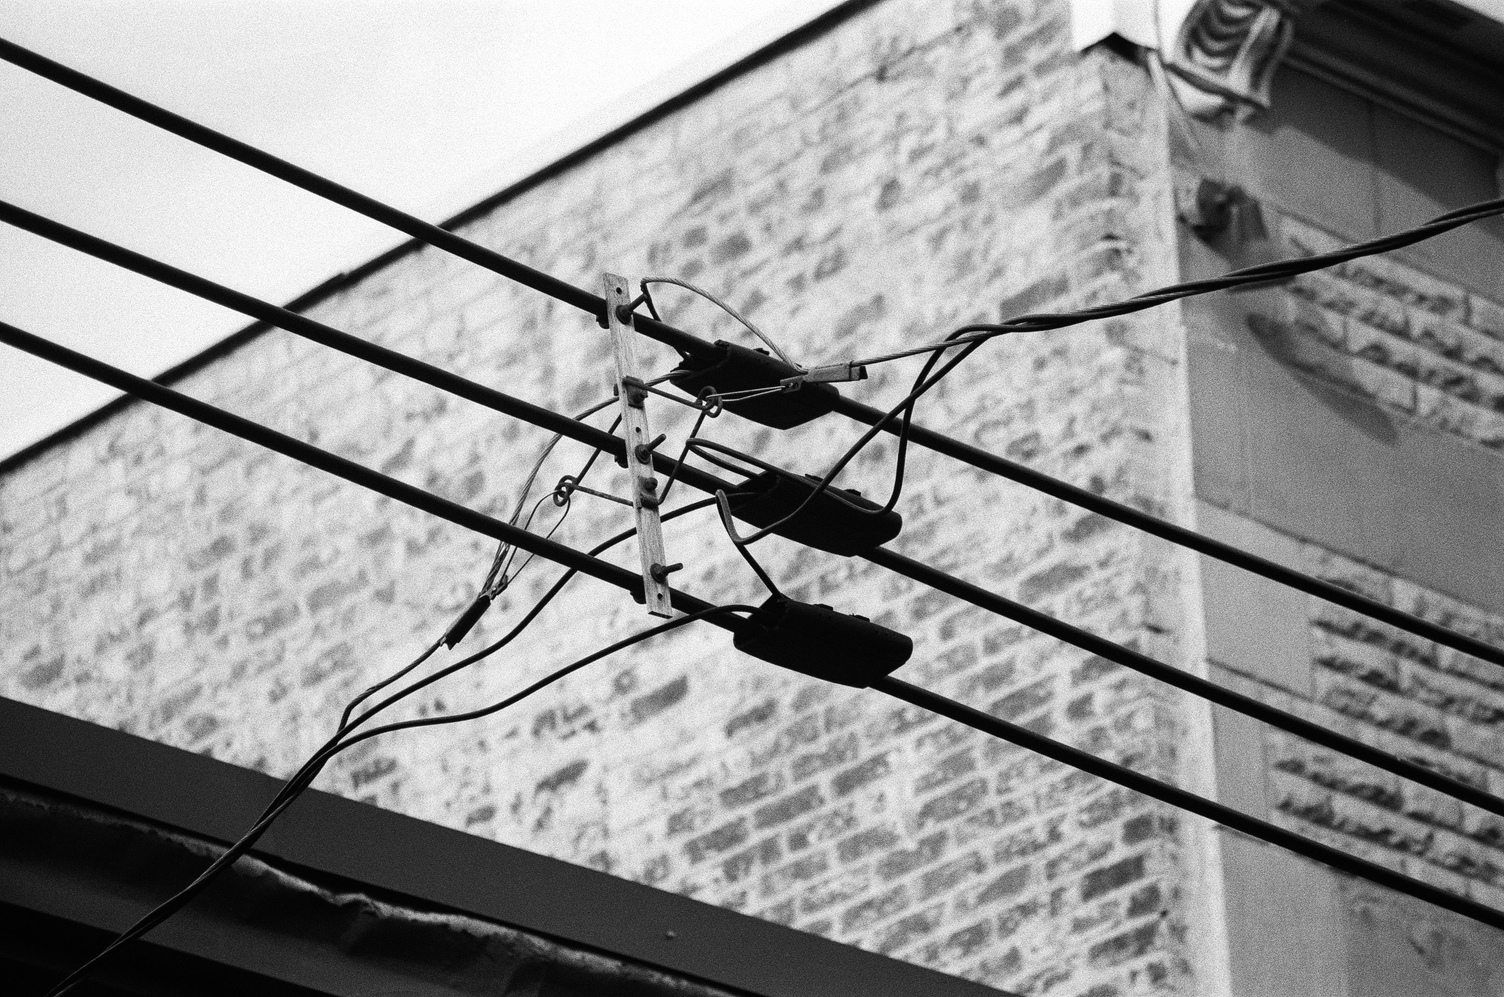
[0,0,1202,997]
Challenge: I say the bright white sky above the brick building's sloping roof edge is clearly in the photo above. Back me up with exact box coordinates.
[0,0,835,456]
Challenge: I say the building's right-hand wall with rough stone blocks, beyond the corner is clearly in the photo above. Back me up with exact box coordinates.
[1182,74,1504,997]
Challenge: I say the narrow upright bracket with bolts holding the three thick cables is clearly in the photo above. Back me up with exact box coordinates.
[603,274,674,620]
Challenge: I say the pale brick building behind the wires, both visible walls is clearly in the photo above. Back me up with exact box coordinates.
[0,0,1504,997]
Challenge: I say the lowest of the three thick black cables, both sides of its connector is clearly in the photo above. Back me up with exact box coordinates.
[0,322,1504,928]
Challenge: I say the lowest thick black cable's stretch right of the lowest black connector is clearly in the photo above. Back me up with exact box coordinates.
[872,675,1504,929]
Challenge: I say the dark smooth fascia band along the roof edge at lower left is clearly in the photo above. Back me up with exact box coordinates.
[0,698,999,997]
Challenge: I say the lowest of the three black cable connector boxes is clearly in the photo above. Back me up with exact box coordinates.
[732,595,914,689]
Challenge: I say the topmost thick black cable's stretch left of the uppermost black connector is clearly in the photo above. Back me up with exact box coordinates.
[0,39,714,366]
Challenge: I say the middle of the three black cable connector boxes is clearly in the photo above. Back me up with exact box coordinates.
[731,471,904,558]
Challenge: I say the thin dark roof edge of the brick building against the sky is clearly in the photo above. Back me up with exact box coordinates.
[0,0,881,475]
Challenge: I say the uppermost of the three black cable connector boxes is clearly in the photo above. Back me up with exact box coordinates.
[669,340,841,429]
